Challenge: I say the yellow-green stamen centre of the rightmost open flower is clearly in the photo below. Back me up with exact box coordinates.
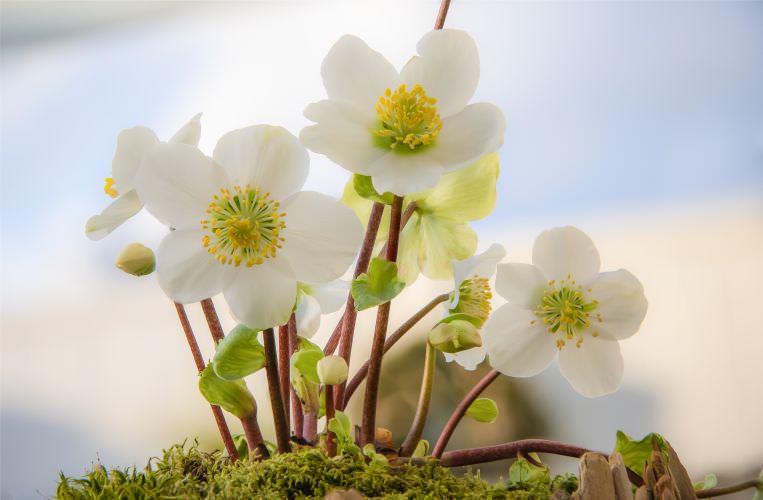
[531,275,602,350]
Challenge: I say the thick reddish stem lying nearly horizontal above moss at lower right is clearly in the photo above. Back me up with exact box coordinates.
[440,439,593,467]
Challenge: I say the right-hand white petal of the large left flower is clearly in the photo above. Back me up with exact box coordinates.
[278,191,363,283]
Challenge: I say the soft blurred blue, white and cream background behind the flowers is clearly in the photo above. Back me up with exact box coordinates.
[0,0,763,498]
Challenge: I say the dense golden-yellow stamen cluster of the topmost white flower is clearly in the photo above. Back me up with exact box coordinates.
[374,84,442,150]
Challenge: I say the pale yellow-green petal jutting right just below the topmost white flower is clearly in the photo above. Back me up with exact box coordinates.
[418,153,499,222]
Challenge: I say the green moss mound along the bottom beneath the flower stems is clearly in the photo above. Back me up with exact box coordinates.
[56,445,569,499]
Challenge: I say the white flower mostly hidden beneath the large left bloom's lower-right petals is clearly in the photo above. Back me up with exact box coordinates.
[295,280,350,338]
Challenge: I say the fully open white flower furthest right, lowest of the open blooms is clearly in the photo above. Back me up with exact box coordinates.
[482,226,647,397]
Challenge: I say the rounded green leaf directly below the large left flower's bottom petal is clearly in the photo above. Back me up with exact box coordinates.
[213,325,265,380]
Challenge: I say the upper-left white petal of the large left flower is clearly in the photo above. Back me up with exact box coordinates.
[136,143,230,228]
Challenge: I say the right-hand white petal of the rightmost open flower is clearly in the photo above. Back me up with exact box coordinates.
[589,269,647,340]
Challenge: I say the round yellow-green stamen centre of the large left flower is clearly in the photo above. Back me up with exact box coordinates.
[201,186,286,267]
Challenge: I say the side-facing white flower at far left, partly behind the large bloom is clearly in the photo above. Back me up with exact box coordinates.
[85,113,201,240]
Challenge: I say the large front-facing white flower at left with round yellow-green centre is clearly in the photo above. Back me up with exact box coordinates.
[137,125,362,328]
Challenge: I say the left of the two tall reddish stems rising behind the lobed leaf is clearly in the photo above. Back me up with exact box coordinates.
[334,202,384,410]
